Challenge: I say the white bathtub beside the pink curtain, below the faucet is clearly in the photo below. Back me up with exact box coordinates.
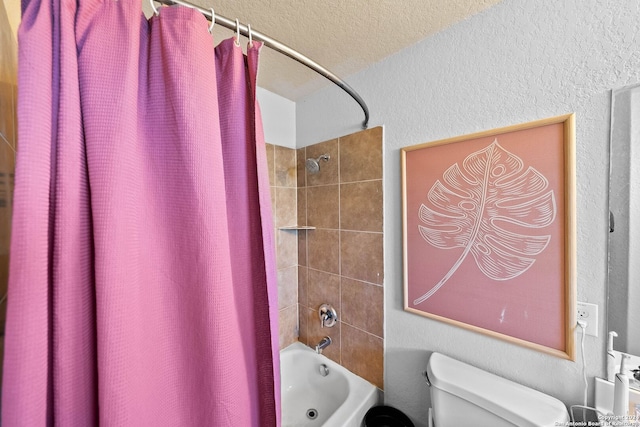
[280,342,379,427]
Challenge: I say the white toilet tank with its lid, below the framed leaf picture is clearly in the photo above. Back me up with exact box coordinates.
[427,353,569,427]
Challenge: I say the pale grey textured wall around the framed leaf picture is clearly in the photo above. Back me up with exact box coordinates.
[296,0,640,425]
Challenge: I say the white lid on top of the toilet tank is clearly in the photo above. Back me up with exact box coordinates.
[427,353,569,426]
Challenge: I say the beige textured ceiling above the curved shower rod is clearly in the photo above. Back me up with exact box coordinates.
[181,0,501,101]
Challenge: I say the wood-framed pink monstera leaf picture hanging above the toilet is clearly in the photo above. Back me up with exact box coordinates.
[401,114,576,360]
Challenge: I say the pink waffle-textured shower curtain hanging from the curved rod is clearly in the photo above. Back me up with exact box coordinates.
[2,0,280,427]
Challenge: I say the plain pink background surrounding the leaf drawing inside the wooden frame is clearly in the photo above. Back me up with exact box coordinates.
[405,123,566,350]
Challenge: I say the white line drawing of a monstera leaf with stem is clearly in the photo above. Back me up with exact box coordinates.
[413,139,556,305]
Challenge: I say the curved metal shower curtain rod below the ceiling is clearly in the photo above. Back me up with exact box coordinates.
[151,0,369,129]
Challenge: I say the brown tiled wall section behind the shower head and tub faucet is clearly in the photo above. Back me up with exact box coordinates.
[297,127,384,389]
